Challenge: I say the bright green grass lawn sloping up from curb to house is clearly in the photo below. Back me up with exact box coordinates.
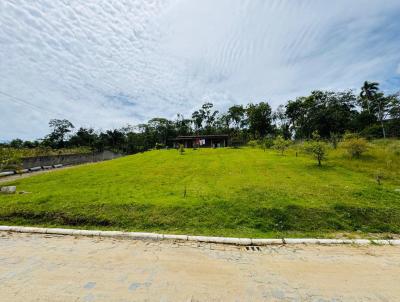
[0,141,400,237]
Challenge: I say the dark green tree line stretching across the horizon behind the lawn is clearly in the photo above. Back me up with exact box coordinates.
[3,81,400,154]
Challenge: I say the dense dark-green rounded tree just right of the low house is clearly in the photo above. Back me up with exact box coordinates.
[246,102,273,138]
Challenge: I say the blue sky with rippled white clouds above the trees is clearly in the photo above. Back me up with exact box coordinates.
[0,0,400,141]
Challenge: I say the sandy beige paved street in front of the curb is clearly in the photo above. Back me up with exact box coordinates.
[0,232,400,302]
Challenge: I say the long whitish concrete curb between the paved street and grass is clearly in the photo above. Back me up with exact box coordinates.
[0,225,400,246]
